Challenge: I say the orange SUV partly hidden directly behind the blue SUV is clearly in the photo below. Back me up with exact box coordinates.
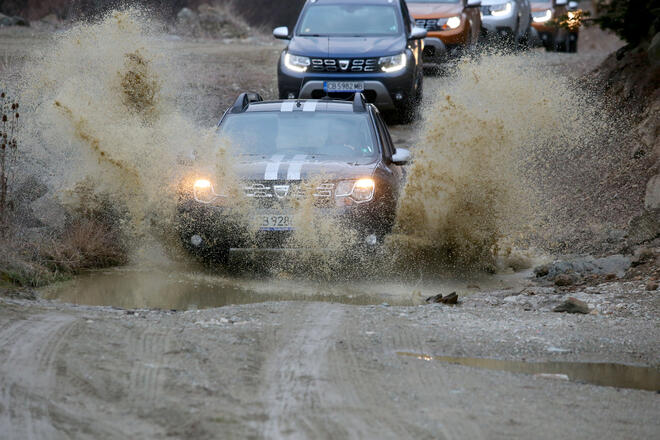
[406,0,481,63]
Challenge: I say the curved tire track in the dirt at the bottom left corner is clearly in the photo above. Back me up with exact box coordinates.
[0,314,76,440]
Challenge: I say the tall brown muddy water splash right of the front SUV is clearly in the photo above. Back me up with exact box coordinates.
[389,54,628,270]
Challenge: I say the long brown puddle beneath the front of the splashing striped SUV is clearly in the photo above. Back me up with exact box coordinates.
[41,267,529,310]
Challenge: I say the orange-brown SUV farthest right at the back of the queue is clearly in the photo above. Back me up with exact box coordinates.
[532,0,579,52]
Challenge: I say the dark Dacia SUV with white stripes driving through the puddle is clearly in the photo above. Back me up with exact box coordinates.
[177,93,410,264]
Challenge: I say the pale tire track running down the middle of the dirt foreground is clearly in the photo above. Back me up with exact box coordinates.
[261,303,343,439]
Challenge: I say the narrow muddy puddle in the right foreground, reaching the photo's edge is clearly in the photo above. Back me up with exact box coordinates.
[397,352,660,391]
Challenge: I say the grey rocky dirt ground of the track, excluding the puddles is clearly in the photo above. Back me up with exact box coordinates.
[0,9,660,439]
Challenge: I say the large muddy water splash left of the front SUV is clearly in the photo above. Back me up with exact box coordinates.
[23,9,237,248]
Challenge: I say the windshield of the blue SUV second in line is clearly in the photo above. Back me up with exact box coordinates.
[298,4,401,36]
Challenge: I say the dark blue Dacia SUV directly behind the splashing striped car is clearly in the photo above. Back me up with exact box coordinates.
[273,0,426,122]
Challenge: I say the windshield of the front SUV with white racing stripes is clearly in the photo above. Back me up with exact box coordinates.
[220,111,379,164]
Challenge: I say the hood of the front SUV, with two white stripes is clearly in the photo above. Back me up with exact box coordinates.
[235,156,378,181]
